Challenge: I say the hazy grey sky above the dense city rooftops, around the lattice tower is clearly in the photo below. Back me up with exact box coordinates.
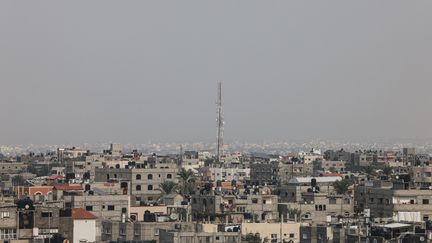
[0,0,432,144]
